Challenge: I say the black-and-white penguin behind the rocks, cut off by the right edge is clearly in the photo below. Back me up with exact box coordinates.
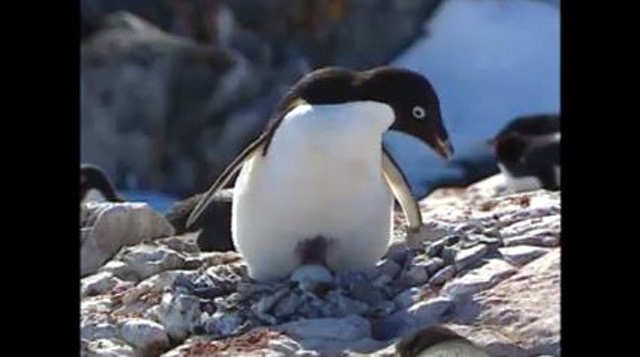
[489,114,560,192]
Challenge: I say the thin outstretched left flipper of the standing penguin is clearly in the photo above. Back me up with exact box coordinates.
[187,135,268,228]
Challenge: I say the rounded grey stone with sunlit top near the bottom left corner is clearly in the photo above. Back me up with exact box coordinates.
[120,319,169,355]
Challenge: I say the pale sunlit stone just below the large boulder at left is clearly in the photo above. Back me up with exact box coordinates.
[116,244,185,279]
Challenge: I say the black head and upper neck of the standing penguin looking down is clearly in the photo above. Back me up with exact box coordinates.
[281,67,453,159]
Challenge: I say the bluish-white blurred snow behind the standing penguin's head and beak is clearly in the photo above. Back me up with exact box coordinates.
[385,0,560,196]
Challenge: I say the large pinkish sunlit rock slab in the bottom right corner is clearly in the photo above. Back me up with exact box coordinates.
[450,248,560,357]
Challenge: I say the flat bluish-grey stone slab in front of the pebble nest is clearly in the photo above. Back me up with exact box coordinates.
[277,315,371,341]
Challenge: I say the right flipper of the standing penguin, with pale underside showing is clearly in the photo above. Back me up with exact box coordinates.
[382,147,422,232]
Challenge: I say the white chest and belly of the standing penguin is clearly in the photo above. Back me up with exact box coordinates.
[232,102,393,280]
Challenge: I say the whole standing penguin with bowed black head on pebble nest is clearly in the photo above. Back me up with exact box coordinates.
[187,67,453,280]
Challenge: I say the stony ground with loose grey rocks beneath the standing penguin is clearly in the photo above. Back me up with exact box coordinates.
[80,176,561,356]
